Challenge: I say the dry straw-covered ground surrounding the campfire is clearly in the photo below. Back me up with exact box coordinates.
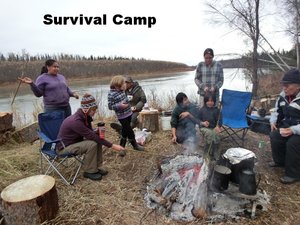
[0,121,300,225]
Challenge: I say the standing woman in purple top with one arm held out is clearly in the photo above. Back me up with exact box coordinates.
[19,59,79,118]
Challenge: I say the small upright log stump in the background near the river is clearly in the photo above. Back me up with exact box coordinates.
[139,110,159,132]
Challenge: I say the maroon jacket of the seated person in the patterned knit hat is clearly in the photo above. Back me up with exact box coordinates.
[57,109,112,149]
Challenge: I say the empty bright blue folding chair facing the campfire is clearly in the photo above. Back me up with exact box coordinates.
[221,89,252,147]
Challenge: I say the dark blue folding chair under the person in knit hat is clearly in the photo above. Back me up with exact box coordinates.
[38,111,83,185]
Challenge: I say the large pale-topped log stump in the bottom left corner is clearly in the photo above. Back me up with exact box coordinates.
[1,175,59,225]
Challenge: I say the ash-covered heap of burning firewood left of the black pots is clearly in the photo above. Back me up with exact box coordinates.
[146,155,210,221]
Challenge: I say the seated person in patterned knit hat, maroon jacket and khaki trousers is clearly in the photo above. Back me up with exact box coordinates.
[58,94,124,180]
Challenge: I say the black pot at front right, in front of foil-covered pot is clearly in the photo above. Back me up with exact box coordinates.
[239,169,260,195]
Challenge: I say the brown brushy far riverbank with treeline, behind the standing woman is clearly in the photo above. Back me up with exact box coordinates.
[0,54,190,83]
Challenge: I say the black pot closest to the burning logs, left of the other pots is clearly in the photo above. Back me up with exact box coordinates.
[212,165,231,191]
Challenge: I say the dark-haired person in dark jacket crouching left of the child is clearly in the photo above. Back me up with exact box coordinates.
[170,92,199,149]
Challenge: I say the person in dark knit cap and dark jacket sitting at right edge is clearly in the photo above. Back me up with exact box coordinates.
[269,69,300,184]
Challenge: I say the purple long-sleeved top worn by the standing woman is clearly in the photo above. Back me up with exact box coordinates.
[31,73,73,107]
